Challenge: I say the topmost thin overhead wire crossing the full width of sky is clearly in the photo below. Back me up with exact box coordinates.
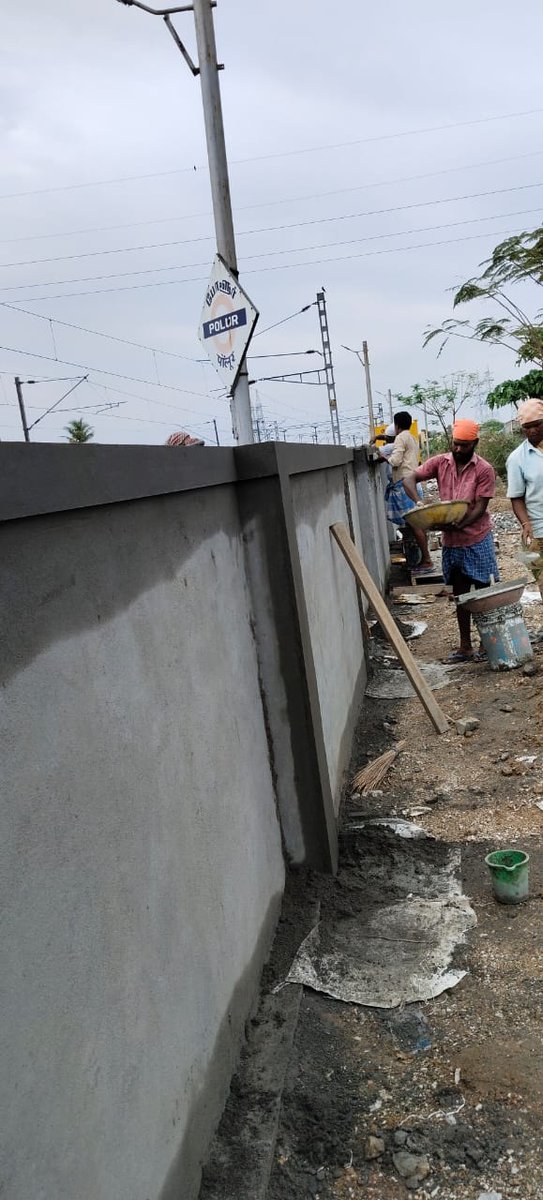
[0,108,543,200]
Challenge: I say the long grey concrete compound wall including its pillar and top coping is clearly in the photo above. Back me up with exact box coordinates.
[0,445,389,1200]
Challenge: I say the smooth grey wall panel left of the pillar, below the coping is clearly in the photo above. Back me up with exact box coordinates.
[0,487,284,1200]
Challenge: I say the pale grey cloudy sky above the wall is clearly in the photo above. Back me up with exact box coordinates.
[0,0,543,444]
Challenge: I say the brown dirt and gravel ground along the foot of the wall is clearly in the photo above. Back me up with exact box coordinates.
[199,500,543,1200]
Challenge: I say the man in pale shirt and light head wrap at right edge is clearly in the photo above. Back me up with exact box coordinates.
[507,400,543,596]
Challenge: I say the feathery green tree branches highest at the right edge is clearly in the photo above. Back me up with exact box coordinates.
[424,226,543,367]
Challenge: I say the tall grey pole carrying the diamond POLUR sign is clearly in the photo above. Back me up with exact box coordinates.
[115,0,255,443]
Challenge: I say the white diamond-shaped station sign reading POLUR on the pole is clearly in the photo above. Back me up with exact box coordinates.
[198,254,258,391]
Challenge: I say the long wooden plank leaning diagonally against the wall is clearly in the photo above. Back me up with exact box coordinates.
[330,521,449,733]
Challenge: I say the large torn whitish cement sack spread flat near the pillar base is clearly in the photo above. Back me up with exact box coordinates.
[276,896,477,1008]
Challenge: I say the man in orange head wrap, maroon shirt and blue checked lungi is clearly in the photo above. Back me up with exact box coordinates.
[404,419,500,662]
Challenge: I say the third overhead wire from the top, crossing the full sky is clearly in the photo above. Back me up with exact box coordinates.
[0,180,543,272]
